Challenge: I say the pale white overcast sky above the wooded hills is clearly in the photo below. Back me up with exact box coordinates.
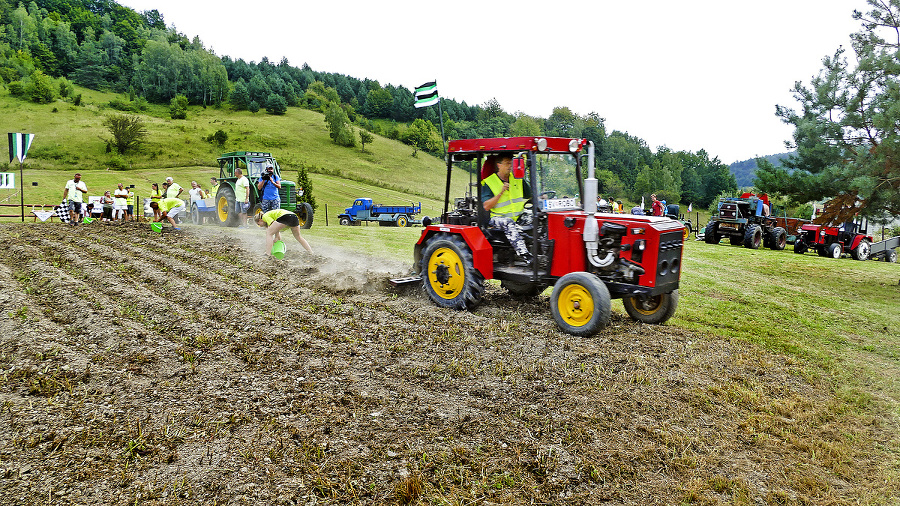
[119,0,866,163]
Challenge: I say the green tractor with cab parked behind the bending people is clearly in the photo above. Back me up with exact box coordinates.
[214,151,313,228]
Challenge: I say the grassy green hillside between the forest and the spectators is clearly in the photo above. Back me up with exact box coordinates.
[0,88,466,223]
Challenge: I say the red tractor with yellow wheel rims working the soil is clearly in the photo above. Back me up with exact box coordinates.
[392,137,684,336]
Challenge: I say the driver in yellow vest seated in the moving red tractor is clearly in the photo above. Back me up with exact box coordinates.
[481,155,531,263]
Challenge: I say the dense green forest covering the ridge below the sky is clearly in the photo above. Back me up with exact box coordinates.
[0,0,737,206]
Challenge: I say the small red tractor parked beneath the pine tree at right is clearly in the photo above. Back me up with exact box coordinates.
[794,221,873,260]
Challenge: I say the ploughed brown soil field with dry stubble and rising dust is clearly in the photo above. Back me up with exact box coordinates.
[0,224,896,505]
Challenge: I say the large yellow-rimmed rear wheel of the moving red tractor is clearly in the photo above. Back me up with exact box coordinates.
[421,234,484,309]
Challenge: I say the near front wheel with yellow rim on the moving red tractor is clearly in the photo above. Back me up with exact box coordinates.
[550,272,611,337]
